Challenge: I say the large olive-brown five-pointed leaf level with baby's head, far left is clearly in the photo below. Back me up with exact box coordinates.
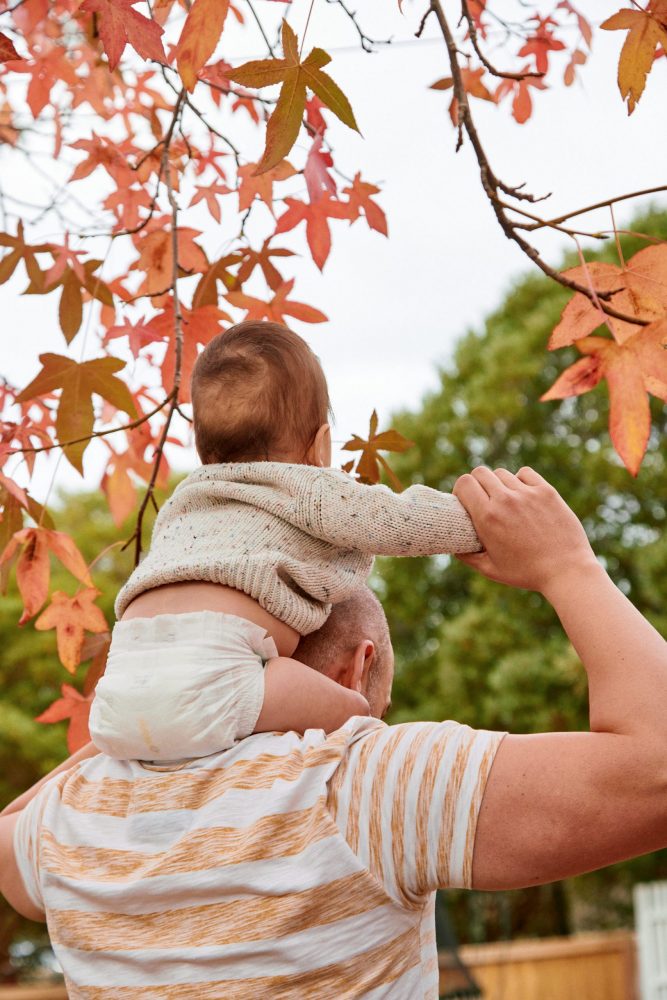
[16,353,136,474]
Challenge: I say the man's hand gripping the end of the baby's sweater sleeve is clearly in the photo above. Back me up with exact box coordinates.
[453,467,596,593]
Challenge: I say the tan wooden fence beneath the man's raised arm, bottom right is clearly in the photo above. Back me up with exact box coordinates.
[440,931,639,1000]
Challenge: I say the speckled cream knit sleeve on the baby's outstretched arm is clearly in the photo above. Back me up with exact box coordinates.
[311,469,482,556]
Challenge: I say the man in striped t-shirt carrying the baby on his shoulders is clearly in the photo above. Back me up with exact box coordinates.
[0,469,667,1000]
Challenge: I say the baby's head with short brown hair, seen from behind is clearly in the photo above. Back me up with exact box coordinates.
[190,320,331,467]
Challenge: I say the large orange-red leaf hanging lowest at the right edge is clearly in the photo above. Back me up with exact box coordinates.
[541,319,667,476]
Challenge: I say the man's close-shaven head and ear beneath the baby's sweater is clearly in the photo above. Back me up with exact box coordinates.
[294,587,394,719]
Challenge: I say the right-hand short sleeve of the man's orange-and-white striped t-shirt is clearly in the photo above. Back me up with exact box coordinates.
[330,721,505,907]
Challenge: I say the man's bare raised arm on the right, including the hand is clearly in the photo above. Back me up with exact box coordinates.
[454,468,667,889]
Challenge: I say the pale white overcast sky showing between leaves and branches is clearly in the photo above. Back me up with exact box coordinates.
[0,0,667,499]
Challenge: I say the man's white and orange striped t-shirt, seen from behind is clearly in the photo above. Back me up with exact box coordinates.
[15,718,503,1000]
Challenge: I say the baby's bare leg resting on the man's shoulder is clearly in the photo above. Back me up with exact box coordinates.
[255,656,370,733]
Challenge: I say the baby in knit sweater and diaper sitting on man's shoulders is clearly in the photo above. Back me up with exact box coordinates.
[90,321,480,762]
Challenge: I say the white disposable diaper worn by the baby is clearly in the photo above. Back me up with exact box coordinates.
[89,611,278,761]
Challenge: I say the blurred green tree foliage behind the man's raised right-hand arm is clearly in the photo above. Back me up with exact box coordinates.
[377,207,667,938]
